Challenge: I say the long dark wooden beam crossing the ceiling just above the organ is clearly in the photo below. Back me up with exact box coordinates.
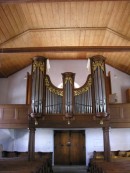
[0,46,130,54]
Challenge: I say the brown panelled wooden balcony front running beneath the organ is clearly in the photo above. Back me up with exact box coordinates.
[0,103,130,128]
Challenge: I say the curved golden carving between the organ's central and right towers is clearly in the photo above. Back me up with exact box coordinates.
[74,77,92,96]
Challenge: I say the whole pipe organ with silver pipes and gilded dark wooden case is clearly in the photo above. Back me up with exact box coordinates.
[31,56,107,118]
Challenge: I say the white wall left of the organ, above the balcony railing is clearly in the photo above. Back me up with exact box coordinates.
[0,66,31,104]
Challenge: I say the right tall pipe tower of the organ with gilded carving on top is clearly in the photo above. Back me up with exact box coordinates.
[90,56,107,117]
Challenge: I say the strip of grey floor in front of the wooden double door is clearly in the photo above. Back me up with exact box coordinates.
[53,165,87,173]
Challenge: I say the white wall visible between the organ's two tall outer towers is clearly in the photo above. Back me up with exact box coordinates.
[48,60,88,86]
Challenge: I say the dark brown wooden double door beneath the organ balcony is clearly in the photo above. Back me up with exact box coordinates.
[54,130,86,165]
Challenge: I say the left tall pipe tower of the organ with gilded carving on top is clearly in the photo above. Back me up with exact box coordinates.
[31,57,46,117]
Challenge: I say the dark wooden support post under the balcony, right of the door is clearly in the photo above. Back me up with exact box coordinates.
[103,127,111,161]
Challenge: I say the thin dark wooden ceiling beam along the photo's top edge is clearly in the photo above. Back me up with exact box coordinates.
[0,0,122,3]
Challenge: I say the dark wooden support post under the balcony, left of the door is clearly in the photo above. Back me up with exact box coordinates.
[28,127,36,161]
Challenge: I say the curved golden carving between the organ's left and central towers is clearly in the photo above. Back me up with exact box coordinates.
[45,77,63,96]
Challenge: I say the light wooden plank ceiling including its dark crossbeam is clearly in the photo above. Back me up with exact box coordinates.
[0,0,130,77]
